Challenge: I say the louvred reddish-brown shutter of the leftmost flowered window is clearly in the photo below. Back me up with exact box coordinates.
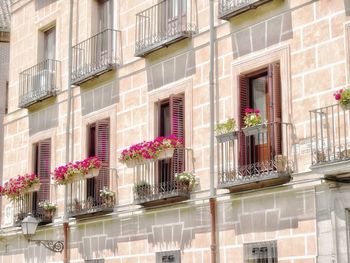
[37,139,51,202]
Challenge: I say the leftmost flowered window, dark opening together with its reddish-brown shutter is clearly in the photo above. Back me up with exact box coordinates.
[32,139,51,217]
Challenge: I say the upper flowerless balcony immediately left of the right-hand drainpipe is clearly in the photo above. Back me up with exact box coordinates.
[135,0,197,57]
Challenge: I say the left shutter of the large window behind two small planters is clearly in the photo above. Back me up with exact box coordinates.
[238,75,249,165]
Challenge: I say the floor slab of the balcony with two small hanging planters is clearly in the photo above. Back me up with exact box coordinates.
[218,171,292,193]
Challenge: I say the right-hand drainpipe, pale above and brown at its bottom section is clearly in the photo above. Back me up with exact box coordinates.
[209,0,217,263]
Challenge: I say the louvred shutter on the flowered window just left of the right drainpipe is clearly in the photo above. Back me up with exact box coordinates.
[170,94,185,176]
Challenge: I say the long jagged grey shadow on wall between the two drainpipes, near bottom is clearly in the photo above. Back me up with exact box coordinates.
[71,205,210,259]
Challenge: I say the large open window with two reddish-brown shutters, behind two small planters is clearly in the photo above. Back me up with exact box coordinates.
[239,63,282,165]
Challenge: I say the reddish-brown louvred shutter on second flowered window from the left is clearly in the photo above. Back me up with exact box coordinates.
[95,119,110,198]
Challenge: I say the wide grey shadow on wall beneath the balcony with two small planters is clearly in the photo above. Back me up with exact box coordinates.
[218,190,316,238]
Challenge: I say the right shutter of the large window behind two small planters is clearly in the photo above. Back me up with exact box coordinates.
[268,63,282,159]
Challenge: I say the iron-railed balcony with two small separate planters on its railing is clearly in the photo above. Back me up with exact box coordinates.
[217,123,294,193]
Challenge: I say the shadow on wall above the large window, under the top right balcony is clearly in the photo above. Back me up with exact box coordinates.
[230,0,293,59]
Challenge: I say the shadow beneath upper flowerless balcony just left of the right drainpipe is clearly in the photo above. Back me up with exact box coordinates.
[146,39,196,91]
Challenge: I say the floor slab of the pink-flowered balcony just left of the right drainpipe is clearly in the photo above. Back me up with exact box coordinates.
[134,192,190,207]
